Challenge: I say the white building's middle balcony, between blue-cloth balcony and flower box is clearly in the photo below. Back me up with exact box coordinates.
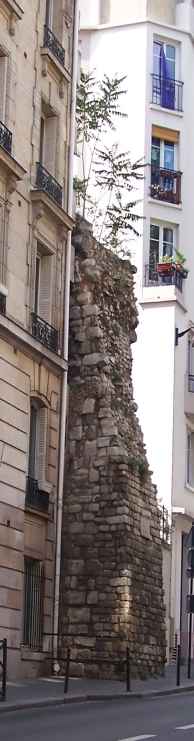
[150,165,181,206]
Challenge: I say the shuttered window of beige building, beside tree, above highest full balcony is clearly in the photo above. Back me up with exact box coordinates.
[39,103,58,176]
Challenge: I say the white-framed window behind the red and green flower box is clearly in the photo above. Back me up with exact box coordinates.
[149,223,176,280]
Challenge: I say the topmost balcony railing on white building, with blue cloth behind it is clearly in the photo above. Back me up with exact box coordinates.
[152,74,183,112]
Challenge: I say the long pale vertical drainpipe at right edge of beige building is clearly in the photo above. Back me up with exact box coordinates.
[53,0,79,671]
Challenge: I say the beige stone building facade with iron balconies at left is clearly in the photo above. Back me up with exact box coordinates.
[0,0,77,677]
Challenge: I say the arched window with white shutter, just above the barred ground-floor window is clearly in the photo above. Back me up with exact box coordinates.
[28,399,48,488]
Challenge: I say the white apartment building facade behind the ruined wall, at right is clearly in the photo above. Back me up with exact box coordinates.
[80,0,194,654]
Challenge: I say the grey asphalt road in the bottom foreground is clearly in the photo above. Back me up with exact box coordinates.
[0,693,194,741]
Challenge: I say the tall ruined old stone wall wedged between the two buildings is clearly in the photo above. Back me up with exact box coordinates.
[60,221,165,676]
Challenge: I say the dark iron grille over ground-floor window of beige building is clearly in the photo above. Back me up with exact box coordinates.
[24,558,44,651]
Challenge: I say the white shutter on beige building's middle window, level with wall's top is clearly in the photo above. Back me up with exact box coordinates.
[38,255,52,324]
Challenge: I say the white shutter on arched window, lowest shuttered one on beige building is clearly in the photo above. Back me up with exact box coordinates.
[36,407,48,482]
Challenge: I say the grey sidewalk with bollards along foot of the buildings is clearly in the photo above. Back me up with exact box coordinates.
[0,665,194,713]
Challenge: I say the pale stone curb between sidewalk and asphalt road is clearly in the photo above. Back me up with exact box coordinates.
[0,685,194,715]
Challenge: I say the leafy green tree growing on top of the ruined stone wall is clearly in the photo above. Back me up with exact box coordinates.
[74,72,143,254]
